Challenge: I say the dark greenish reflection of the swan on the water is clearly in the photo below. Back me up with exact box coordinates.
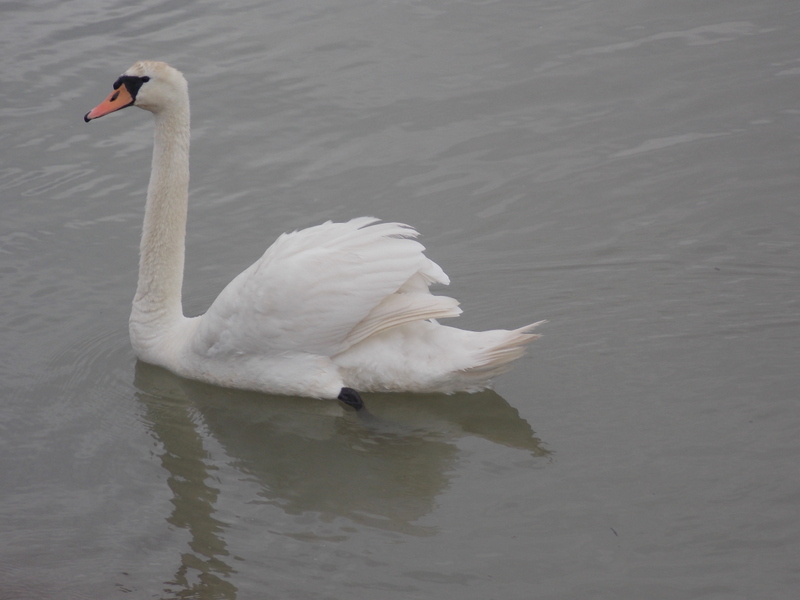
[135,363,549,598]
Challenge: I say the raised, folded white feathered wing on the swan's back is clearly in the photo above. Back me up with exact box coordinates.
[195,217,460,356]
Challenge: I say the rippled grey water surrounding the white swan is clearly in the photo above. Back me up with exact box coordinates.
[0,0,800,599]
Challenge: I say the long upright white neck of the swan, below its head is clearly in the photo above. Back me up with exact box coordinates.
[131,97,189,343]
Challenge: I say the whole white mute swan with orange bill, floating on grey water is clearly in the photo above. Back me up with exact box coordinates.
[84,61,541,410]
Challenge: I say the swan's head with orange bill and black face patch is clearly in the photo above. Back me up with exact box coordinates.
[83,60,189,123]
